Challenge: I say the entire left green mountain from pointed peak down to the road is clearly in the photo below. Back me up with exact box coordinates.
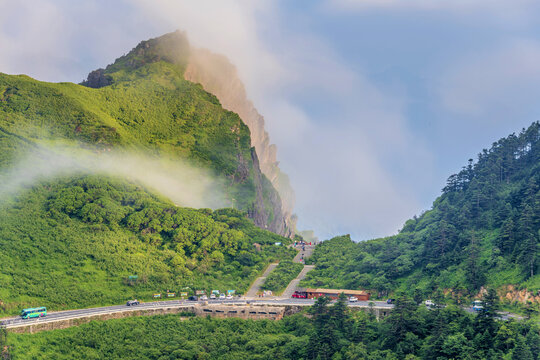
[0,33,294,313]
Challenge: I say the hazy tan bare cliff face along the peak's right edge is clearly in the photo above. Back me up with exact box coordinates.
[184,48,296,236]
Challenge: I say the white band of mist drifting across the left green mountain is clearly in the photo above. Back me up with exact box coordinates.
[0,146,227,209]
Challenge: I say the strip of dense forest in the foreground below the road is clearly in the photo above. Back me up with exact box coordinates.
[5,291,540,360]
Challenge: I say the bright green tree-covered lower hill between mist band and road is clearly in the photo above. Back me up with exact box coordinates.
[0,176,296,314]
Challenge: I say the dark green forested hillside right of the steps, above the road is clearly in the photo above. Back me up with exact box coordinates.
[304,122,540,296]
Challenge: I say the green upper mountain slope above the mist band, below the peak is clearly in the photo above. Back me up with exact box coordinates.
[0,33,279,230]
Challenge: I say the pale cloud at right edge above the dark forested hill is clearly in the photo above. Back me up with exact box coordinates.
[435,39,540,120]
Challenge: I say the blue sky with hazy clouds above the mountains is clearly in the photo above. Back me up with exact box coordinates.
[0,0,540,241]
